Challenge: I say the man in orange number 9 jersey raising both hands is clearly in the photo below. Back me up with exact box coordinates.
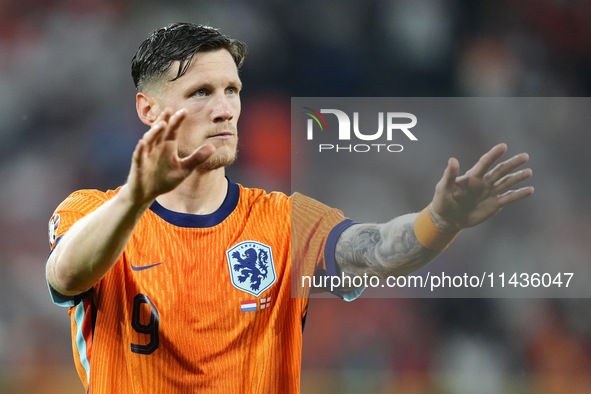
[47,24,533,393]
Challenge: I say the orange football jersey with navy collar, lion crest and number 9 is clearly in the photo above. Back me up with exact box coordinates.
[50,181,352,394]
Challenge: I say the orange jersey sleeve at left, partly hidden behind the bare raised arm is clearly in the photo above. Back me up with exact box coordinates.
[47,190,108,307]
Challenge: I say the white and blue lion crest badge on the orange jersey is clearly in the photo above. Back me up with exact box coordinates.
[226,241,277,296]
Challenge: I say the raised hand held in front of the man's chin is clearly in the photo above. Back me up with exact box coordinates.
[127,108,215,204]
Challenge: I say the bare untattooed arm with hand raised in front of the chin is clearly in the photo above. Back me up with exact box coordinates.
[46,109,215,296]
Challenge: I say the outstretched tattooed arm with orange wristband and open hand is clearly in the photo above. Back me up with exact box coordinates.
[335,144,534,278]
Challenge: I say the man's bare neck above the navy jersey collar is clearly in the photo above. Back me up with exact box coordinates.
[156,167,228,215]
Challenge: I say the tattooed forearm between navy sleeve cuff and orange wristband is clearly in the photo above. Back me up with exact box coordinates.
[335,214,440,278]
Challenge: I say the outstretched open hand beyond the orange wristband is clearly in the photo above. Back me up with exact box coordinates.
[430,144,534,232]
